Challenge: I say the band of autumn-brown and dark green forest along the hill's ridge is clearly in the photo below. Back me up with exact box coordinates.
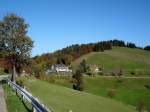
[32,40,150,69]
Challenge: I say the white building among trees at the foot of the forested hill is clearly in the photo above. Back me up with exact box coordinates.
[51,64,71,72]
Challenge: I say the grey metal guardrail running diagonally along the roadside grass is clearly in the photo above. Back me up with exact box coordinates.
[7,80,53,112]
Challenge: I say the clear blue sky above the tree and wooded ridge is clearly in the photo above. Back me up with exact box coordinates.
[0,0,150,56]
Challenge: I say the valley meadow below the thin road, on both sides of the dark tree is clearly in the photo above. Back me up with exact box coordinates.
[41,76,150,112]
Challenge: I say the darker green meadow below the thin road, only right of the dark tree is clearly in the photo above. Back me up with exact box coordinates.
[85,77,150,111]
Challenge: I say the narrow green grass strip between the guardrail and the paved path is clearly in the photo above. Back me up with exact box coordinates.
[3,84,31,112]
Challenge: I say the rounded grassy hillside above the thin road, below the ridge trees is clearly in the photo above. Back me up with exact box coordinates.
[72,47,150,74]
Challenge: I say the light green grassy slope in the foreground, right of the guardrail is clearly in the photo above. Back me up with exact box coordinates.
[18,79,134,112]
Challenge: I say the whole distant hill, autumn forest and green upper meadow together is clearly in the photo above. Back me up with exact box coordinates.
[31,39,149,74]
